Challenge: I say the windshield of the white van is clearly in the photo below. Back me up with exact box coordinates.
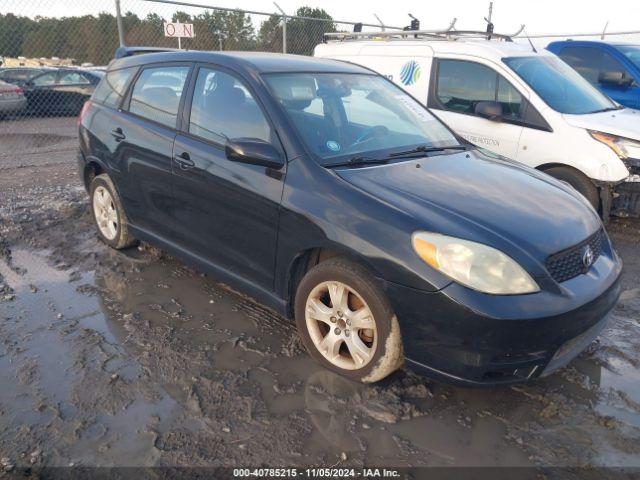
[502,56,617,115]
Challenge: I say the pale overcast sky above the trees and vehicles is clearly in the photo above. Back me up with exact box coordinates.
[5,0,640,42]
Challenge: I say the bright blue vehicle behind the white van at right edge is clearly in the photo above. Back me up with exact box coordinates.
[547,40,640,109]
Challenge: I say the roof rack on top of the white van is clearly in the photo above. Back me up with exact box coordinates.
[324,25,524,42]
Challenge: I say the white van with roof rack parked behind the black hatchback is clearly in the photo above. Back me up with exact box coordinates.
[314,31,640,219]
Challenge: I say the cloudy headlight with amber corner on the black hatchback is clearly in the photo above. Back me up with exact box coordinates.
[411,232,540,295]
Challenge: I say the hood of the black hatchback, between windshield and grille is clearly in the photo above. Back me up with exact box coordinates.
[336,151,601,261]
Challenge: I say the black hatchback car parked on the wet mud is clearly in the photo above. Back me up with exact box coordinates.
[79,48,621,385]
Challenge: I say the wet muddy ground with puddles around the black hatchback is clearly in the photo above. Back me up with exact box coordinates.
[0,118,640,478]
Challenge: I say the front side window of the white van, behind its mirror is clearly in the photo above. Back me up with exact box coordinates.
[436,60,523,120]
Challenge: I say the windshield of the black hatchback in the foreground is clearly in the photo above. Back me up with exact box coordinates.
[265,73,459,165]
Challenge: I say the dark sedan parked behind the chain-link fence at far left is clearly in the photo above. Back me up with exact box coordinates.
[22,68,104,115]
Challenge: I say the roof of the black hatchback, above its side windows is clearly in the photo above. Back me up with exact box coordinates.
[109,50,371,73]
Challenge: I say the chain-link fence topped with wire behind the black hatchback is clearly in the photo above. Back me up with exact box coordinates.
[0,0,638,142]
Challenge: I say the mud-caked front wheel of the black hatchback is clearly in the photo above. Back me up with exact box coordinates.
[295,257,404,383]
